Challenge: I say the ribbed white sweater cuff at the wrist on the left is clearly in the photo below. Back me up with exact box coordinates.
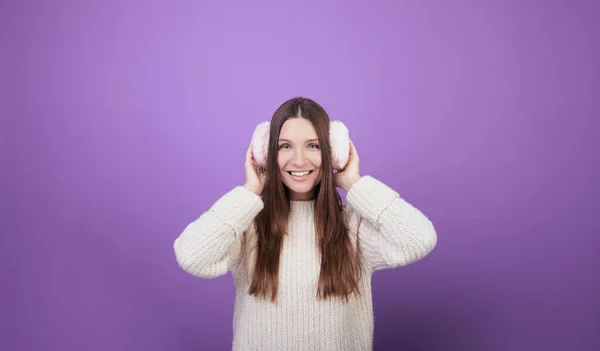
[211,186,264,235]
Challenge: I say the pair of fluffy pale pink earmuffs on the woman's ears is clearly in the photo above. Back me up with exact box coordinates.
[252,121,350,171]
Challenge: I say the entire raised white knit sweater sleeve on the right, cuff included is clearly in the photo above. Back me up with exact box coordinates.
[346,176,437,271]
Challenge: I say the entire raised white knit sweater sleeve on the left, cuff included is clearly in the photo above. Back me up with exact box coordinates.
[173,186,263,278]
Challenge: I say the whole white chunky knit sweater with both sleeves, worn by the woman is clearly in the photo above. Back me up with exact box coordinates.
[174,176,437,351]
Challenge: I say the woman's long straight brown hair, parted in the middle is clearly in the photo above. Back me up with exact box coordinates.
[249,97,361,301]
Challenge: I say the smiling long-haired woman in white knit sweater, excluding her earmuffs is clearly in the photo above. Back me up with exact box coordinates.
[174,98,437,351]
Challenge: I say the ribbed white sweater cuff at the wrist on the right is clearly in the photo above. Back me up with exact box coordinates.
[346,176,400,226]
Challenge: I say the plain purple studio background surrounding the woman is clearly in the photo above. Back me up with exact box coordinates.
[0,0,600,351]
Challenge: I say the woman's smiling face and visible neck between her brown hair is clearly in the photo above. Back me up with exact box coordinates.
[277,118,322,200]
